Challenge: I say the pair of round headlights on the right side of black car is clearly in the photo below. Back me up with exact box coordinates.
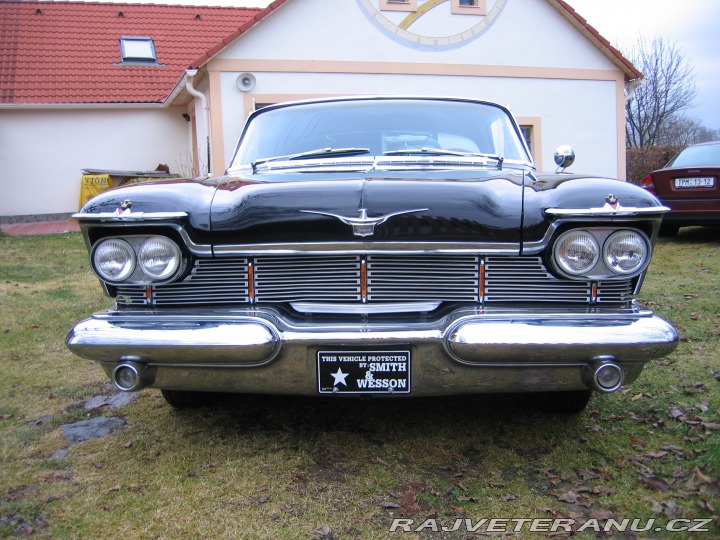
[553,228,650,279]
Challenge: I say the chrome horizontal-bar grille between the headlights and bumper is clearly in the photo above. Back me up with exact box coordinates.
[115,254,633,306]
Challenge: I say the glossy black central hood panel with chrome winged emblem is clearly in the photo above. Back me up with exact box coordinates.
[211,171,523,246]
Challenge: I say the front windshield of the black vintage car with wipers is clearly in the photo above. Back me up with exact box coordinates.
[231,99,530,168]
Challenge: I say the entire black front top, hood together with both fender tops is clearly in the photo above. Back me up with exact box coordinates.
[76,168,662,251]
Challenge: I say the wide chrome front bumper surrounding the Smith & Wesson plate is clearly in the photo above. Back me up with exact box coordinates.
[67,308,678,396]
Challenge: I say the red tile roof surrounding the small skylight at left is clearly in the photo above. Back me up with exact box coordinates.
[0,1,261,104]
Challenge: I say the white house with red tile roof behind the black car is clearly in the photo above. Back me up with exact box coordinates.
[0,0,642,220]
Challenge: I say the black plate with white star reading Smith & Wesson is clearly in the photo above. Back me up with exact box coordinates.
[317,350,410,394]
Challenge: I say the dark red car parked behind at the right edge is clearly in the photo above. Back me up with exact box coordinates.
[640,141,720,236]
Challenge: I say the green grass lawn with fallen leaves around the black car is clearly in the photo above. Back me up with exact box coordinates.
[0,228,720,540]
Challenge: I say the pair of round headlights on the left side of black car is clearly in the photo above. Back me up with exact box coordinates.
[92,236,182,283]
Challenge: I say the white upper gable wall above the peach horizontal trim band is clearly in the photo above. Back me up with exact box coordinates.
[217,0,614,69]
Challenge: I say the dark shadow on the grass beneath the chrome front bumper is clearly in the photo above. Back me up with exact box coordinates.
[162,394,584,445]
